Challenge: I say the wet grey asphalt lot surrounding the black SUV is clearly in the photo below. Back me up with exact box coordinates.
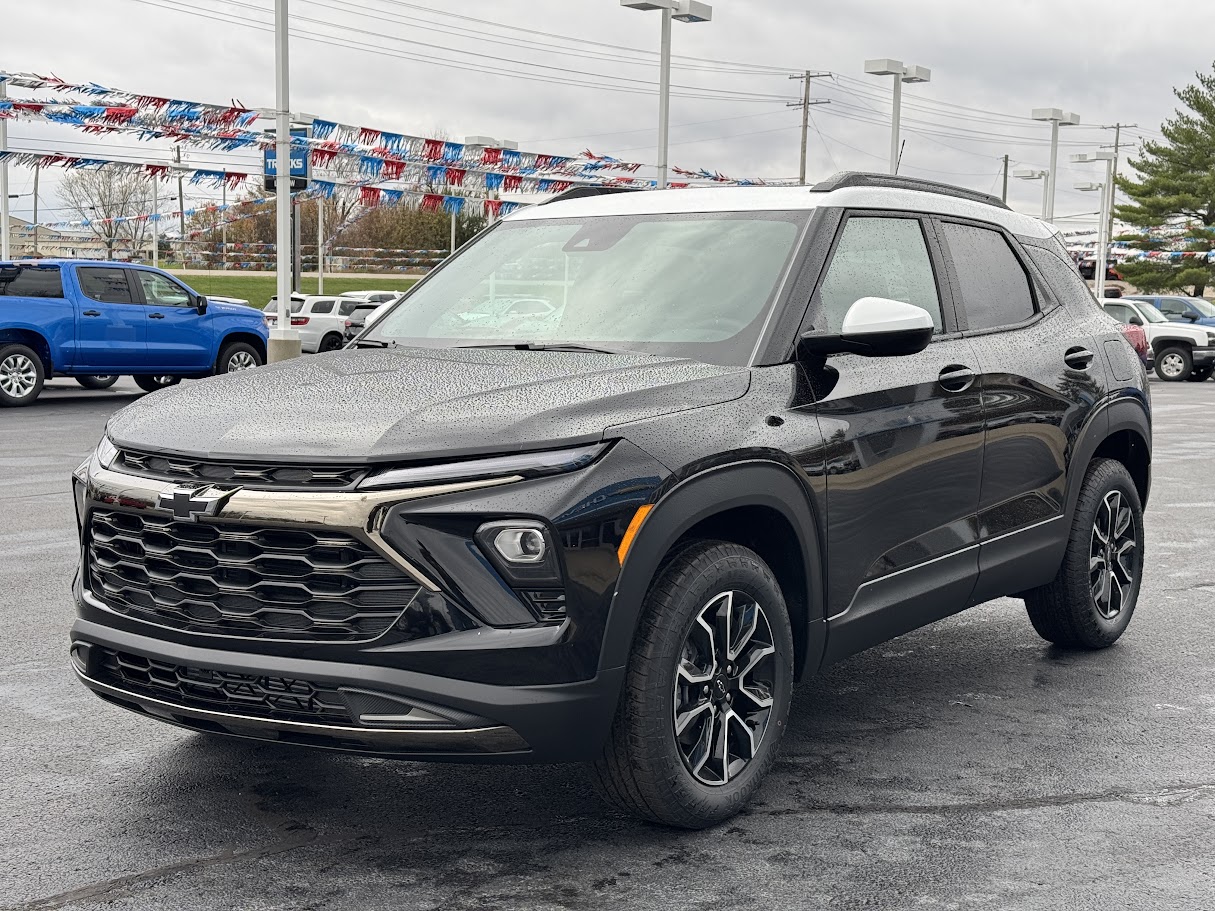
[0,379,1215,911]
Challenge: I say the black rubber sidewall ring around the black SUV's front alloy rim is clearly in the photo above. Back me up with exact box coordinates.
[634,544,793,824]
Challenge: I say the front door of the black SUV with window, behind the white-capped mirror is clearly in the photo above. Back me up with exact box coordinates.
[803,211,983,661]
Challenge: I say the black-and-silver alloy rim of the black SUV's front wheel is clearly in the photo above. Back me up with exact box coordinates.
[673,592,776,786]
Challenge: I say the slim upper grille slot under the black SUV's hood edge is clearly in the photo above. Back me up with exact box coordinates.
[114,449,367,491]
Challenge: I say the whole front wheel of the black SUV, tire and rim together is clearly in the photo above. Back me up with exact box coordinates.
[592,541,793,828]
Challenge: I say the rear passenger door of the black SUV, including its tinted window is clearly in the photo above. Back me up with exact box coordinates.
[938,219,1106,602]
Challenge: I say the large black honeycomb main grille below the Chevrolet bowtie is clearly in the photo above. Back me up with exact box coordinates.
[87,510,418,643]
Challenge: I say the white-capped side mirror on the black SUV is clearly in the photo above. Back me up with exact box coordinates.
[797,298,933,357]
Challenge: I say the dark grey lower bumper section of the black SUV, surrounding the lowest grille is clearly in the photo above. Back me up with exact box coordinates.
[72,619,623,763]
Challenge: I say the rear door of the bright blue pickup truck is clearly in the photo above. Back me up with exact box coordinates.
[75,266,147,373]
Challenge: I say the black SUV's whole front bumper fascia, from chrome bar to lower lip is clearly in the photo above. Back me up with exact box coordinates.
[72,445,660,762]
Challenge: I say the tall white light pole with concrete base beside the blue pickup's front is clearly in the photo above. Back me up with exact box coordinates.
[266,0,300,363]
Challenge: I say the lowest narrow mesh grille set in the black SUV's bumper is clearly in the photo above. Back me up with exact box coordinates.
[91,647,354,725]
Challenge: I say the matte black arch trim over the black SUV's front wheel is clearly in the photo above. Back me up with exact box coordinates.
[599,459,826,678]
